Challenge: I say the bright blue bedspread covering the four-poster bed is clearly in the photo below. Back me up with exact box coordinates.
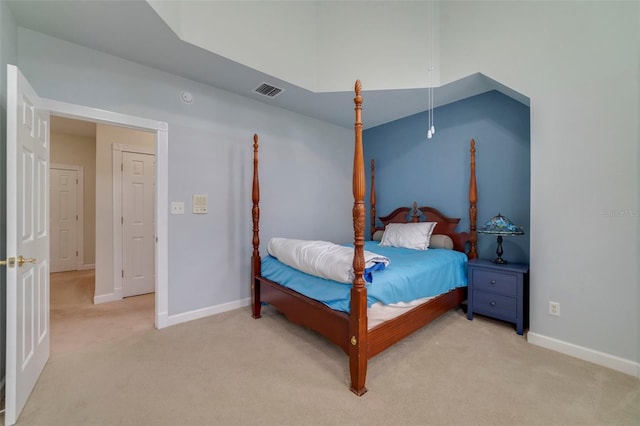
[261,241,467,312]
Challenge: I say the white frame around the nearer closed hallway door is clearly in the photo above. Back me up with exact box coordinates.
[111,143,158,300]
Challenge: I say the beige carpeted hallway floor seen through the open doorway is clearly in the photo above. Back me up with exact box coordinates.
[50,269,155,354]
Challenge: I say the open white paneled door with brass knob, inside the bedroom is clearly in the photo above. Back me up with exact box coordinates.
[5,65,49,425]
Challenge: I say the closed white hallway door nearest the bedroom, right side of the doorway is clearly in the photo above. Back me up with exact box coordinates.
[122,151,155,297]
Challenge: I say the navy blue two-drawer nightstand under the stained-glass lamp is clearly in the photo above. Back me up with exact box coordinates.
[467,259,529,334]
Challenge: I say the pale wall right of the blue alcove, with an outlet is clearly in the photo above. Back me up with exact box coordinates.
[440,1,640,375]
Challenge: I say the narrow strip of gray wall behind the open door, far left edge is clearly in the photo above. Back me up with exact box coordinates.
[0,1,18,394]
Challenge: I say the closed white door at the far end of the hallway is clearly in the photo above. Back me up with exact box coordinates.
[49,168,78,272]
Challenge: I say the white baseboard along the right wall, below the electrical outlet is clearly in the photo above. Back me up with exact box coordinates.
[527,332,640,378]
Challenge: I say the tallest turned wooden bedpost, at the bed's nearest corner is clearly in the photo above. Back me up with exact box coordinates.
[349,80,368,395]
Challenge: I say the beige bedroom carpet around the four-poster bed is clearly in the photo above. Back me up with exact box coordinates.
[11,294,640,426]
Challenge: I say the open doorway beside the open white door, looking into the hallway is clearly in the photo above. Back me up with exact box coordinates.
[49,114,155,353]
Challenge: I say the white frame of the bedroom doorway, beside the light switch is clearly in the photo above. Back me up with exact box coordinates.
[42,98,169,329]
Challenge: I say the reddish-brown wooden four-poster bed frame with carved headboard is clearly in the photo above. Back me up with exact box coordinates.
[251,80,477,396]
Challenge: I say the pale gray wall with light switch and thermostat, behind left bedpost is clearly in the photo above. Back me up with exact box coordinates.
[18,28,353,317]
